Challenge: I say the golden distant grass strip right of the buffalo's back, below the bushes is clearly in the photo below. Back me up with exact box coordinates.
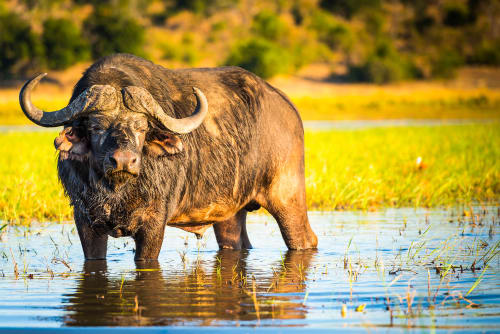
[292,88,500,120]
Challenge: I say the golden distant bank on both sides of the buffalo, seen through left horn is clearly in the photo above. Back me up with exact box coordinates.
[0,83,500,125]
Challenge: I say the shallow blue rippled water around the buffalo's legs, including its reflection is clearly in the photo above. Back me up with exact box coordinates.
[0,207,500,331]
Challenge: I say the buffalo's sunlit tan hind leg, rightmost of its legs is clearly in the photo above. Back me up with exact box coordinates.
[262,167,318,250]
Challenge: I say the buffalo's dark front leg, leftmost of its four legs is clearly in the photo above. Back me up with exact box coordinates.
[74,209,108,260]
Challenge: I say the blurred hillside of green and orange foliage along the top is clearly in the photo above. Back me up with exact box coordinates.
[0,0,500,83]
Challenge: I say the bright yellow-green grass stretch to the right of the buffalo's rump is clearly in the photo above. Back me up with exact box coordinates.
[306,123,500,209]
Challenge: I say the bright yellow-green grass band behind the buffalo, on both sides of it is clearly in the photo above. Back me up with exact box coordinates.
[0,123,500,223]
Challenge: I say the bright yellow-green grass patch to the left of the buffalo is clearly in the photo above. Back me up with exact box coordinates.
[0,132,72,223]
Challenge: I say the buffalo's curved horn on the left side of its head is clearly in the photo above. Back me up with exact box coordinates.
[19,73,117,127]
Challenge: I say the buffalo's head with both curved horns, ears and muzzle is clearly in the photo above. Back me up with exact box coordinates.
[19,74,208,188]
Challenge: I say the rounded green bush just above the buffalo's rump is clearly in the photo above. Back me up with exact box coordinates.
[225,38,293,79]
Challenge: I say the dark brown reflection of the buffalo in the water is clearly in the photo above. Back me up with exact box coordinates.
[64,250,316,326]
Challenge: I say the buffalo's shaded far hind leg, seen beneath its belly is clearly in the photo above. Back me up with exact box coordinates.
[214,209,252,249]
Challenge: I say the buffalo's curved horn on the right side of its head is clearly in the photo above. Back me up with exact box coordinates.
[123,86,208,134]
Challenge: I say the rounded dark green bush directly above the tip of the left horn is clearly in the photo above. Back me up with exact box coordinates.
[42,19,89,69]
